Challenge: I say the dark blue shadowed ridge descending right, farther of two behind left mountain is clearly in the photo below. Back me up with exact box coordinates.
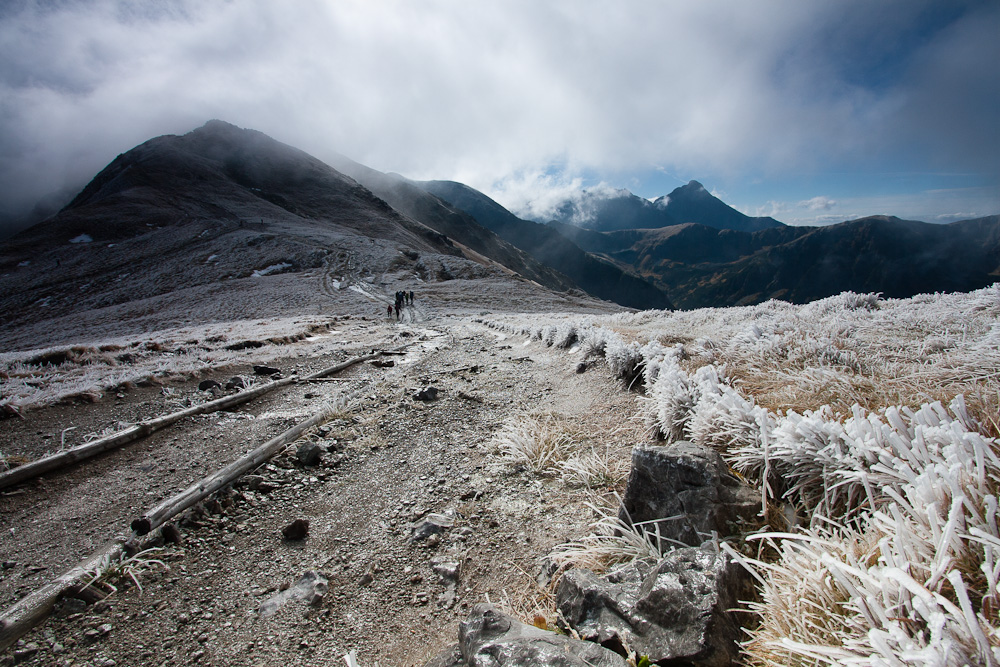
[417,181,673,309]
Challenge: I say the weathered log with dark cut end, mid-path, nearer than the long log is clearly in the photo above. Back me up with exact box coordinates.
[132,410,329,535]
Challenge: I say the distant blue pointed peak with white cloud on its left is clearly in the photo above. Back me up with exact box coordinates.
[546,181,784,232]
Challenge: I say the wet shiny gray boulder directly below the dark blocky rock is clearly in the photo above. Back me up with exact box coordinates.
[556,544,752,667]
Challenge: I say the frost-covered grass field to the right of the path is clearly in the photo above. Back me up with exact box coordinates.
[487,286,1000,665]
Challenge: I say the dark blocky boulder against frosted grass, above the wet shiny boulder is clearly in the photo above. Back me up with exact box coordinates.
[619,441,760,547]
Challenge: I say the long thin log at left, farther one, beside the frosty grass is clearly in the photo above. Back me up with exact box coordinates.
[0,376,297,489]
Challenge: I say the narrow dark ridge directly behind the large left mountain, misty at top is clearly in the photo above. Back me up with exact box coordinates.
[324,156,577,291]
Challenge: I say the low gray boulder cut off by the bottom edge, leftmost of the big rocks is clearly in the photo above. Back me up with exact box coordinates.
[458,604,626,667]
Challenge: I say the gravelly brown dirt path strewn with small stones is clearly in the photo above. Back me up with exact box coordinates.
[0,315,643,667]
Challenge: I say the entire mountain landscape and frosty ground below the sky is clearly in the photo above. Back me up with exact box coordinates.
[0,121,1000,667]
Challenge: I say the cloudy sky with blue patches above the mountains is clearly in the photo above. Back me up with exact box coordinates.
[0,0,1000,236]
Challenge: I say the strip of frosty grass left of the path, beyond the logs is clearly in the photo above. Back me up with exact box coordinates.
[0,318,342,412]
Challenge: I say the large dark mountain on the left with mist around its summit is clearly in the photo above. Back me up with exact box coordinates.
[0,121,612,349]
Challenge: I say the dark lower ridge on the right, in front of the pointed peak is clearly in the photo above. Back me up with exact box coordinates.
[556,216,1000,308]
